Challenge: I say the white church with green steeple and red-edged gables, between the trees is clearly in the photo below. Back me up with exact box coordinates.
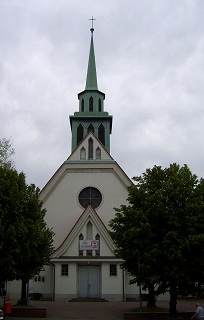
[7,26,139,301]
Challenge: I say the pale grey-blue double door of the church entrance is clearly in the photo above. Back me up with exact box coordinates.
[79,266,100,298]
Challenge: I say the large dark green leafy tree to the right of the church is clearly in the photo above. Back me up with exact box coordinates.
[110,164,204,313]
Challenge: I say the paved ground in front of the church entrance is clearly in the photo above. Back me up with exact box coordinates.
[1,300,204,320]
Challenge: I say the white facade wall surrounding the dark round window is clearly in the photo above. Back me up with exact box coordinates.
[44,169,128,248]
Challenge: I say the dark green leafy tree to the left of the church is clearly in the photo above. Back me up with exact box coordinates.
[0,167,53,303]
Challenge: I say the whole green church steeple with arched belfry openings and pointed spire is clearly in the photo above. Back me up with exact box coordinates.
[69,23,112,153]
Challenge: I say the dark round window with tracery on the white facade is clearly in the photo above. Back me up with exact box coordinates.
[79,187,102,209]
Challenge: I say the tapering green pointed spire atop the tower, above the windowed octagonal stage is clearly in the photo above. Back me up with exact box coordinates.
[85,28,98,90]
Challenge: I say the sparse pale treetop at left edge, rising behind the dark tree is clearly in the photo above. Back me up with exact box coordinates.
[0,138,15,168]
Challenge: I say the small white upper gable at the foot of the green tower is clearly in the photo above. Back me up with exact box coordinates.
[67,131,114,161]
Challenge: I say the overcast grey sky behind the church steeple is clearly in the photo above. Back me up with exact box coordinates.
[0,0,204,188]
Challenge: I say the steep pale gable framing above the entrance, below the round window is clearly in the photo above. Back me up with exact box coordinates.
[51,206,115,259]
